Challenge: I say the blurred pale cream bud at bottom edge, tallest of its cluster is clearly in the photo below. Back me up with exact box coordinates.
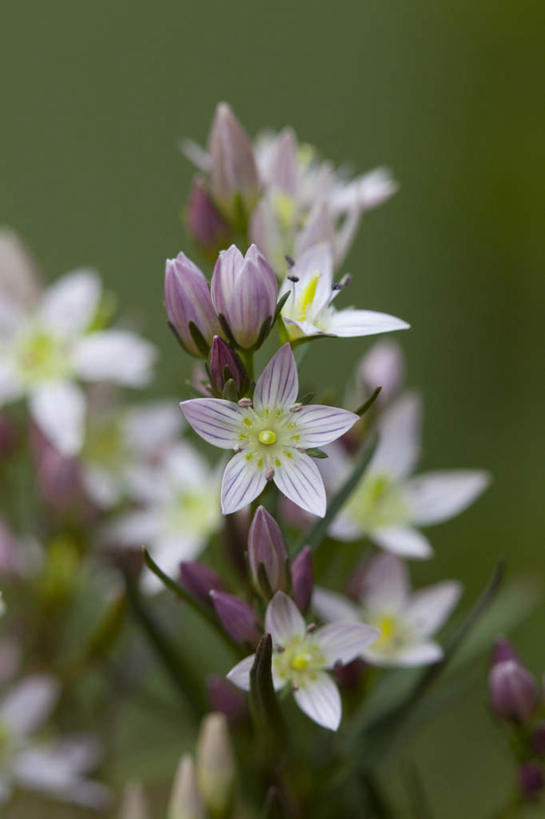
[197,713,235,816]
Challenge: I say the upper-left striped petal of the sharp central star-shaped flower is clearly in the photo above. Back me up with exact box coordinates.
[180,398,244,449]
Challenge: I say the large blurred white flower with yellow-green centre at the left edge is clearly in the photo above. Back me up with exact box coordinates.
[0,262,155,455]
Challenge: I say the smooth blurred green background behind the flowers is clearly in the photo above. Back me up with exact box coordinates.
[0,0,545,819]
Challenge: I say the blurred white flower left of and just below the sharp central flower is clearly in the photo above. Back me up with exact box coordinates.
[104,443,220,591]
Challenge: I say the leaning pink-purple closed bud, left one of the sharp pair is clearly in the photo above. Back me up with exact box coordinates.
[165,253,219,358]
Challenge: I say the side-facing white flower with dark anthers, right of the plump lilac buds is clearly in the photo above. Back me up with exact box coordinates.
[280,244,409,340]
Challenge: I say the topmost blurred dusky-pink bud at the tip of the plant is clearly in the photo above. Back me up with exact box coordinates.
[208,102,259,217]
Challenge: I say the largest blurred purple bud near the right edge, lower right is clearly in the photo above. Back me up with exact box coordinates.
[489,660,538,722]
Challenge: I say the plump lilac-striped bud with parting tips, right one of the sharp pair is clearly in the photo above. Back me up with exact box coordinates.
[211,245,278,349]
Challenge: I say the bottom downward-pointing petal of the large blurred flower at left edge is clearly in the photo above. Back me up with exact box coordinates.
[30,381,85,455]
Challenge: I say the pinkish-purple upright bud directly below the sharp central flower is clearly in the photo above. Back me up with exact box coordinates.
[248,506,288,596]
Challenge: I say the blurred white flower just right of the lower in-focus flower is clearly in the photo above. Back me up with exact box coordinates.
[312,554,461,666]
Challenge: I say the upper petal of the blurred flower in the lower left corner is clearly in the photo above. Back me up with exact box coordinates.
[0,674,60,736]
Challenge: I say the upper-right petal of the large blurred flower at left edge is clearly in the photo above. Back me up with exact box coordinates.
[40,270,101,336]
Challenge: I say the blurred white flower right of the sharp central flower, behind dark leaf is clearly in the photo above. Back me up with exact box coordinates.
[320,394,490,558]
